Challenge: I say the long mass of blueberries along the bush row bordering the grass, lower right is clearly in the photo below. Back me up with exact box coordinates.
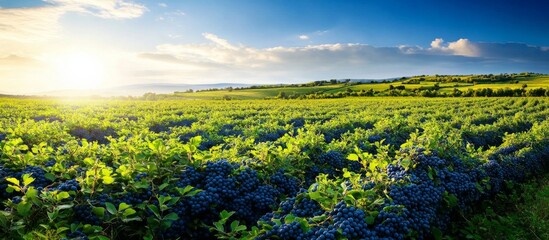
[259,143,549,239]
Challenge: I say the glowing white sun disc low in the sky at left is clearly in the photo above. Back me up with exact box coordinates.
[53,52,105,90]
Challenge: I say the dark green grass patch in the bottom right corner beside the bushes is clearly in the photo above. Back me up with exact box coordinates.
[446,175,549,240]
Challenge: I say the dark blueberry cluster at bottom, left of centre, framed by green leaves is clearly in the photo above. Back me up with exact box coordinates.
[164,160,299,238]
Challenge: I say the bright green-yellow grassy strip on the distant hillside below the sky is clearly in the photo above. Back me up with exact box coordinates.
[168,75,549,100]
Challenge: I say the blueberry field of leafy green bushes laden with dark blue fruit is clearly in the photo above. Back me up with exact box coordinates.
[0,96,549,239]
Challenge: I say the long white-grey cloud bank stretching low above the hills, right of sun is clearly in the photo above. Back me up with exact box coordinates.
[139,33,549,83]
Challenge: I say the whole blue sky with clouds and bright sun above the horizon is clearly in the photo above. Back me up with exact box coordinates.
[0,0,549,94]
